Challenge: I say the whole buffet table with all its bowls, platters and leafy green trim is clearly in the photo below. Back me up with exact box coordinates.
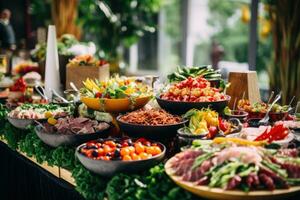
[0,70,300,200]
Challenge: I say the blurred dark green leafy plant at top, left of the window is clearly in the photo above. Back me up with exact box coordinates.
[78,0,161,58]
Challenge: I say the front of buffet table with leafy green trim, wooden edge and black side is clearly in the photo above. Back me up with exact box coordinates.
[0,121,195,200]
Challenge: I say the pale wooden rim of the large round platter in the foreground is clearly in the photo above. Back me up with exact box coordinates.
[165,157,300,200]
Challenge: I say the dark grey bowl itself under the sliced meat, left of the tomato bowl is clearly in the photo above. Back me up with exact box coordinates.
[34,122,111,147]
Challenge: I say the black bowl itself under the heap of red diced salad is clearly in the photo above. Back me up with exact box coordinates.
[156,96,230,114]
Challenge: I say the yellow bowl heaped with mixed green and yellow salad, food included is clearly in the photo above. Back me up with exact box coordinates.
[81,77,152,113]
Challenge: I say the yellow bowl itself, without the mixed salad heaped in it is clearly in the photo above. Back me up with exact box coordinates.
[81,96,151,113]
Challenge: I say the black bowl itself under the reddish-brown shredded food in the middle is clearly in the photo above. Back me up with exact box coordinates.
[117,115,188,141]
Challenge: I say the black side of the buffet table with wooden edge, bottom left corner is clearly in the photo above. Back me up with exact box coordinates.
[0,141,83,200]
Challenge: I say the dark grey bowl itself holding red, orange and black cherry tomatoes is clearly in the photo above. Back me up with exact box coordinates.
[75,139,166,176]
